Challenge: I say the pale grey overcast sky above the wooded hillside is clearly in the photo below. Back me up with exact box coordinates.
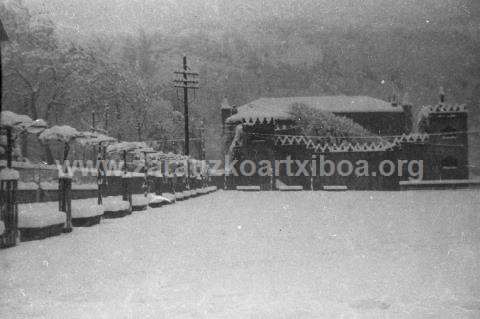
[25,0,480,33]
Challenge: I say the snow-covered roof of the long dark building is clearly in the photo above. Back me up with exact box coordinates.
[227,95,403,123]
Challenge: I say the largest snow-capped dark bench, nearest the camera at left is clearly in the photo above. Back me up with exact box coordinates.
[18,202,66,241]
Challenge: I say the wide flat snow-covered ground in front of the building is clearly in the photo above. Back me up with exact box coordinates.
[0,190,480,318]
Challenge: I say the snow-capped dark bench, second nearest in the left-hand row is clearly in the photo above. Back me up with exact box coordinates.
[72,198,104,227]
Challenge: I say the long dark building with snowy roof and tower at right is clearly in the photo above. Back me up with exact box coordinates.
[222,96,469,189]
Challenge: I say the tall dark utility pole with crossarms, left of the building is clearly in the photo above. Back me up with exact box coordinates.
[173,56,199,156]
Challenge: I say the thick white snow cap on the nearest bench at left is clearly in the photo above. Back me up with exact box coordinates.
[18,202,66,228]
